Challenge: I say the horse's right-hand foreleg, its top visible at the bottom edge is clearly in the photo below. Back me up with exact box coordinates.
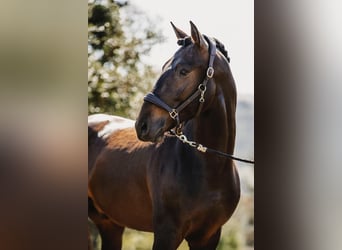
[186,228,221,250]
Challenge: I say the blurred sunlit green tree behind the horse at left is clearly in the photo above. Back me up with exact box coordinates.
[88,0,163,118]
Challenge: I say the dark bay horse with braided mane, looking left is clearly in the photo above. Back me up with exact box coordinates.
[88,22,240,250]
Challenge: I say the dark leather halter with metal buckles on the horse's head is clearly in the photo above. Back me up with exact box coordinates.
[144,36,216,127]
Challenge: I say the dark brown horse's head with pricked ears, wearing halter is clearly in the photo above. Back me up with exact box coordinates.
[135,21,216,142]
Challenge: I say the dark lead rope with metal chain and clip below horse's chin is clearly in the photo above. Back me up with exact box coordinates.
[170,130,255,164]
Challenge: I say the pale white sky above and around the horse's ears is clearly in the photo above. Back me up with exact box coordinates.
[130,0,254,95]
